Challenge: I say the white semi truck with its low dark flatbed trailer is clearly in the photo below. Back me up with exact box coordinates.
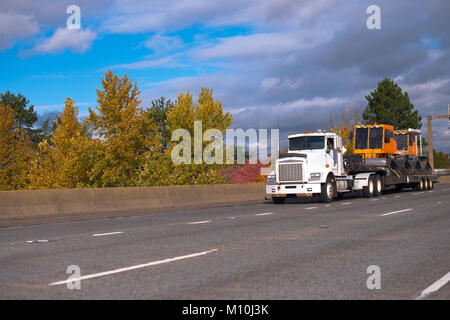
[266,126,437,204]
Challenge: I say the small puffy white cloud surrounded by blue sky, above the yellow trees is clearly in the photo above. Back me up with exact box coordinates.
[26,28,97,54]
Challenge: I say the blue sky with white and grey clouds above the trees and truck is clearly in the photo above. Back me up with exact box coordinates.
[0,0,450,153]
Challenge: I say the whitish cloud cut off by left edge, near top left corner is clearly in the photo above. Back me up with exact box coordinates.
[0,11,39,50]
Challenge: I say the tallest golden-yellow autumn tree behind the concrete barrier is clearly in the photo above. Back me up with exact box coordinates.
[85,71,160,187]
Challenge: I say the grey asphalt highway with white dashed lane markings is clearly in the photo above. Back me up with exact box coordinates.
[0,185,450,300]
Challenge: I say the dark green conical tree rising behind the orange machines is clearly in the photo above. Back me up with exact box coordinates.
[363,78,422,129]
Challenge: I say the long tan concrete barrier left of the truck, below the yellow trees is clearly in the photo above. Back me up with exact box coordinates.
[0,183,265,226]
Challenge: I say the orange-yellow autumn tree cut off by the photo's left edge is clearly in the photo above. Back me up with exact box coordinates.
[0,103,32,190]
